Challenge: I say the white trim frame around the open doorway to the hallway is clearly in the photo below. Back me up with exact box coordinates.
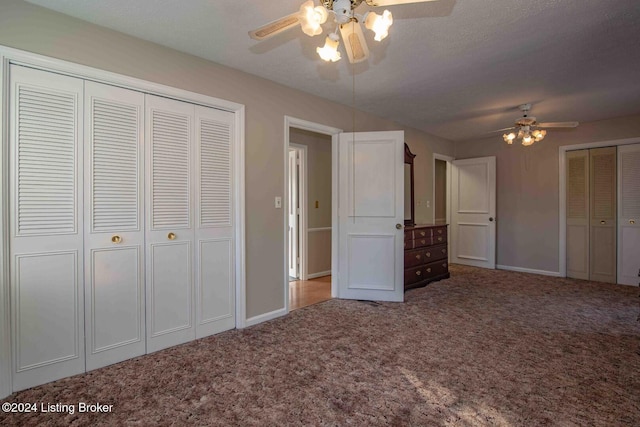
[282,116,342,314]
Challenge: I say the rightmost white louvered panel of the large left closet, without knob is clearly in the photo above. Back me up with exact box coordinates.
[195,106,235,338]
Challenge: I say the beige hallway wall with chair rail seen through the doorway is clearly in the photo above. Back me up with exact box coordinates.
[289,128,331,274]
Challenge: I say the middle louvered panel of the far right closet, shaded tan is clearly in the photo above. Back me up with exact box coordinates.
[589,147,617,283]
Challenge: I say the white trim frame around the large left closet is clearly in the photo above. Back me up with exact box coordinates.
[0,45,247,398]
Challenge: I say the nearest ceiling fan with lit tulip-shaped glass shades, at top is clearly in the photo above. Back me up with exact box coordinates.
[249,0,437,64]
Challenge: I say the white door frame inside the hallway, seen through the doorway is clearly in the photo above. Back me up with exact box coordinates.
[285,142,309,280]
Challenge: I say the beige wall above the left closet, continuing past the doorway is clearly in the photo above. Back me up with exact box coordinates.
[0,0,453,318]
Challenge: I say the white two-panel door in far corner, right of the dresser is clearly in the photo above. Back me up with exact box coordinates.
[451,157,496,269]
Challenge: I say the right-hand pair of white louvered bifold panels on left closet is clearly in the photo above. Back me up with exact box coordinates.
[146,95,235,352]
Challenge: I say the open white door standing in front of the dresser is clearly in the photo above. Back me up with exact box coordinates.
[337,131,404,301]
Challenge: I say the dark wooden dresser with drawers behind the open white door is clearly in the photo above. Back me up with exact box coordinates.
[404,225,449,290]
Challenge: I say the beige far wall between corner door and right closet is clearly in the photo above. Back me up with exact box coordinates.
[455,115,640,272]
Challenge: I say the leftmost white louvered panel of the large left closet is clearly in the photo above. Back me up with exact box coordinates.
[9,65,85,390]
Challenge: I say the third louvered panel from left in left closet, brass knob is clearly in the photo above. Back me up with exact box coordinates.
[145,95,195,352]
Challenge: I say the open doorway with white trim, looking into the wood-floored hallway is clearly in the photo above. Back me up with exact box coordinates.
[285,117,340,311]
